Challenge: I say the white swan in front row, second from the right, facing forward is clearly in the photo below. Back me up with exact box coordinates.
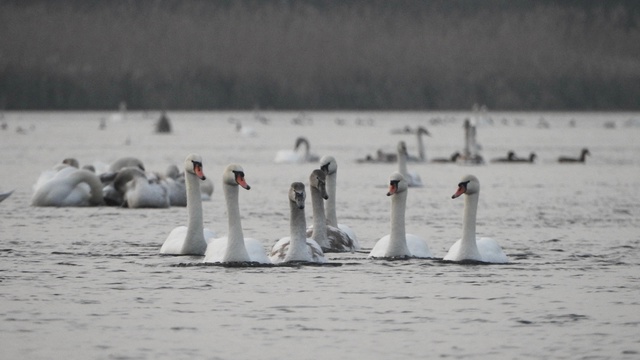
[369,172,433,258]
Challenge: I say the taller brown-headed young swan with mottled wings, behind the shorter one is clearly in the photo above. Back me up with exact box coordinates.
[307,169,356,252]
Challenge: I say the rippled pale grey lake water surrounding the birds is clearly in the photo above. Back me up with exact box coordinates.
[0,112,640,359]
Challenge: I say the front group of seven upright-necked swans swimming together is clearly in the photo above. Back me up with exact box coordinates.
[160,154,508,264]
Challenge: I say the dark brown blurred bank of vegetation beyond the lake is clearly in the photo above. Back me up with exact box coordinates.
[0,0,640,110]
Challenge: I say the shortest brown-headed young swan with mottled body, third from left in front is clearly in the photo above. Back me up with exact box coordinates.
[269,182,327,264]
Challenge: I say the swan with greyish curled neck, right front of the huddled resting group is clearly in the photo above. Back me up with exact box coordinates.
[112,167,170,209]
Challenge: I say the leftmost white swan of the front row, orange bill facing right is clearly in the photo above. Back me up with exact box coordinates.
[160,154,215,255]
